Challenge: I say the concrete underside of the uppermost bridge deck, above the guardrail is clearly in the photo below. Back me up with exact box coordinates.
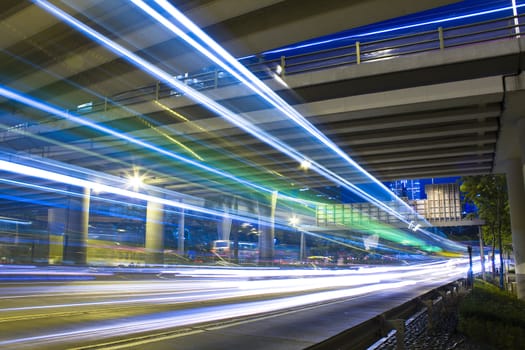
[186,0,457,57]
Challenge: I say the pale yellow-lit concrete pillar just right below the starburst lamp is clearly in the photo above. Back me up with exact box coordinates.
[144,202,164,265]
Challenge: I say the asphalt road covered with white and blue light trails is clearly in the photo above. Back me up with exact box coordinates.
[0,261,466,350]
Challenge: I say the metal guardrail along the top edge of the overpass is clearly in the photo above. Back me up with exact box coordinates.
[85,15,525,112]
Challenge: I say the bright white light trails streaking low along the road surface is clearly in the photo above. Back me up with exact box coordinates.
[0,259,466,348]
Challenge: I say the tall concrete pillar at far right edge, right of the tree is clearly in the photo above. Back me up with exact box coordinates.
[505,159,525,300]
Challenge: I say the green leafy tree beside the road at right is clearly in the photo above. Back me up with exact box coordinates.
[460,174,512,288]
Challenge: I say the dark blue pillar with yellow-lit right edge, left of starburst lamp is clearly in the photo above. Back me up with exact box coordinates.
[63,188,91,265]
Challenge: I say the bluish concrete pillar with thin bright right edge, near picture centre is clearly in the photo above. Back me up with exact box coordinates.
[259,191,277,263]
